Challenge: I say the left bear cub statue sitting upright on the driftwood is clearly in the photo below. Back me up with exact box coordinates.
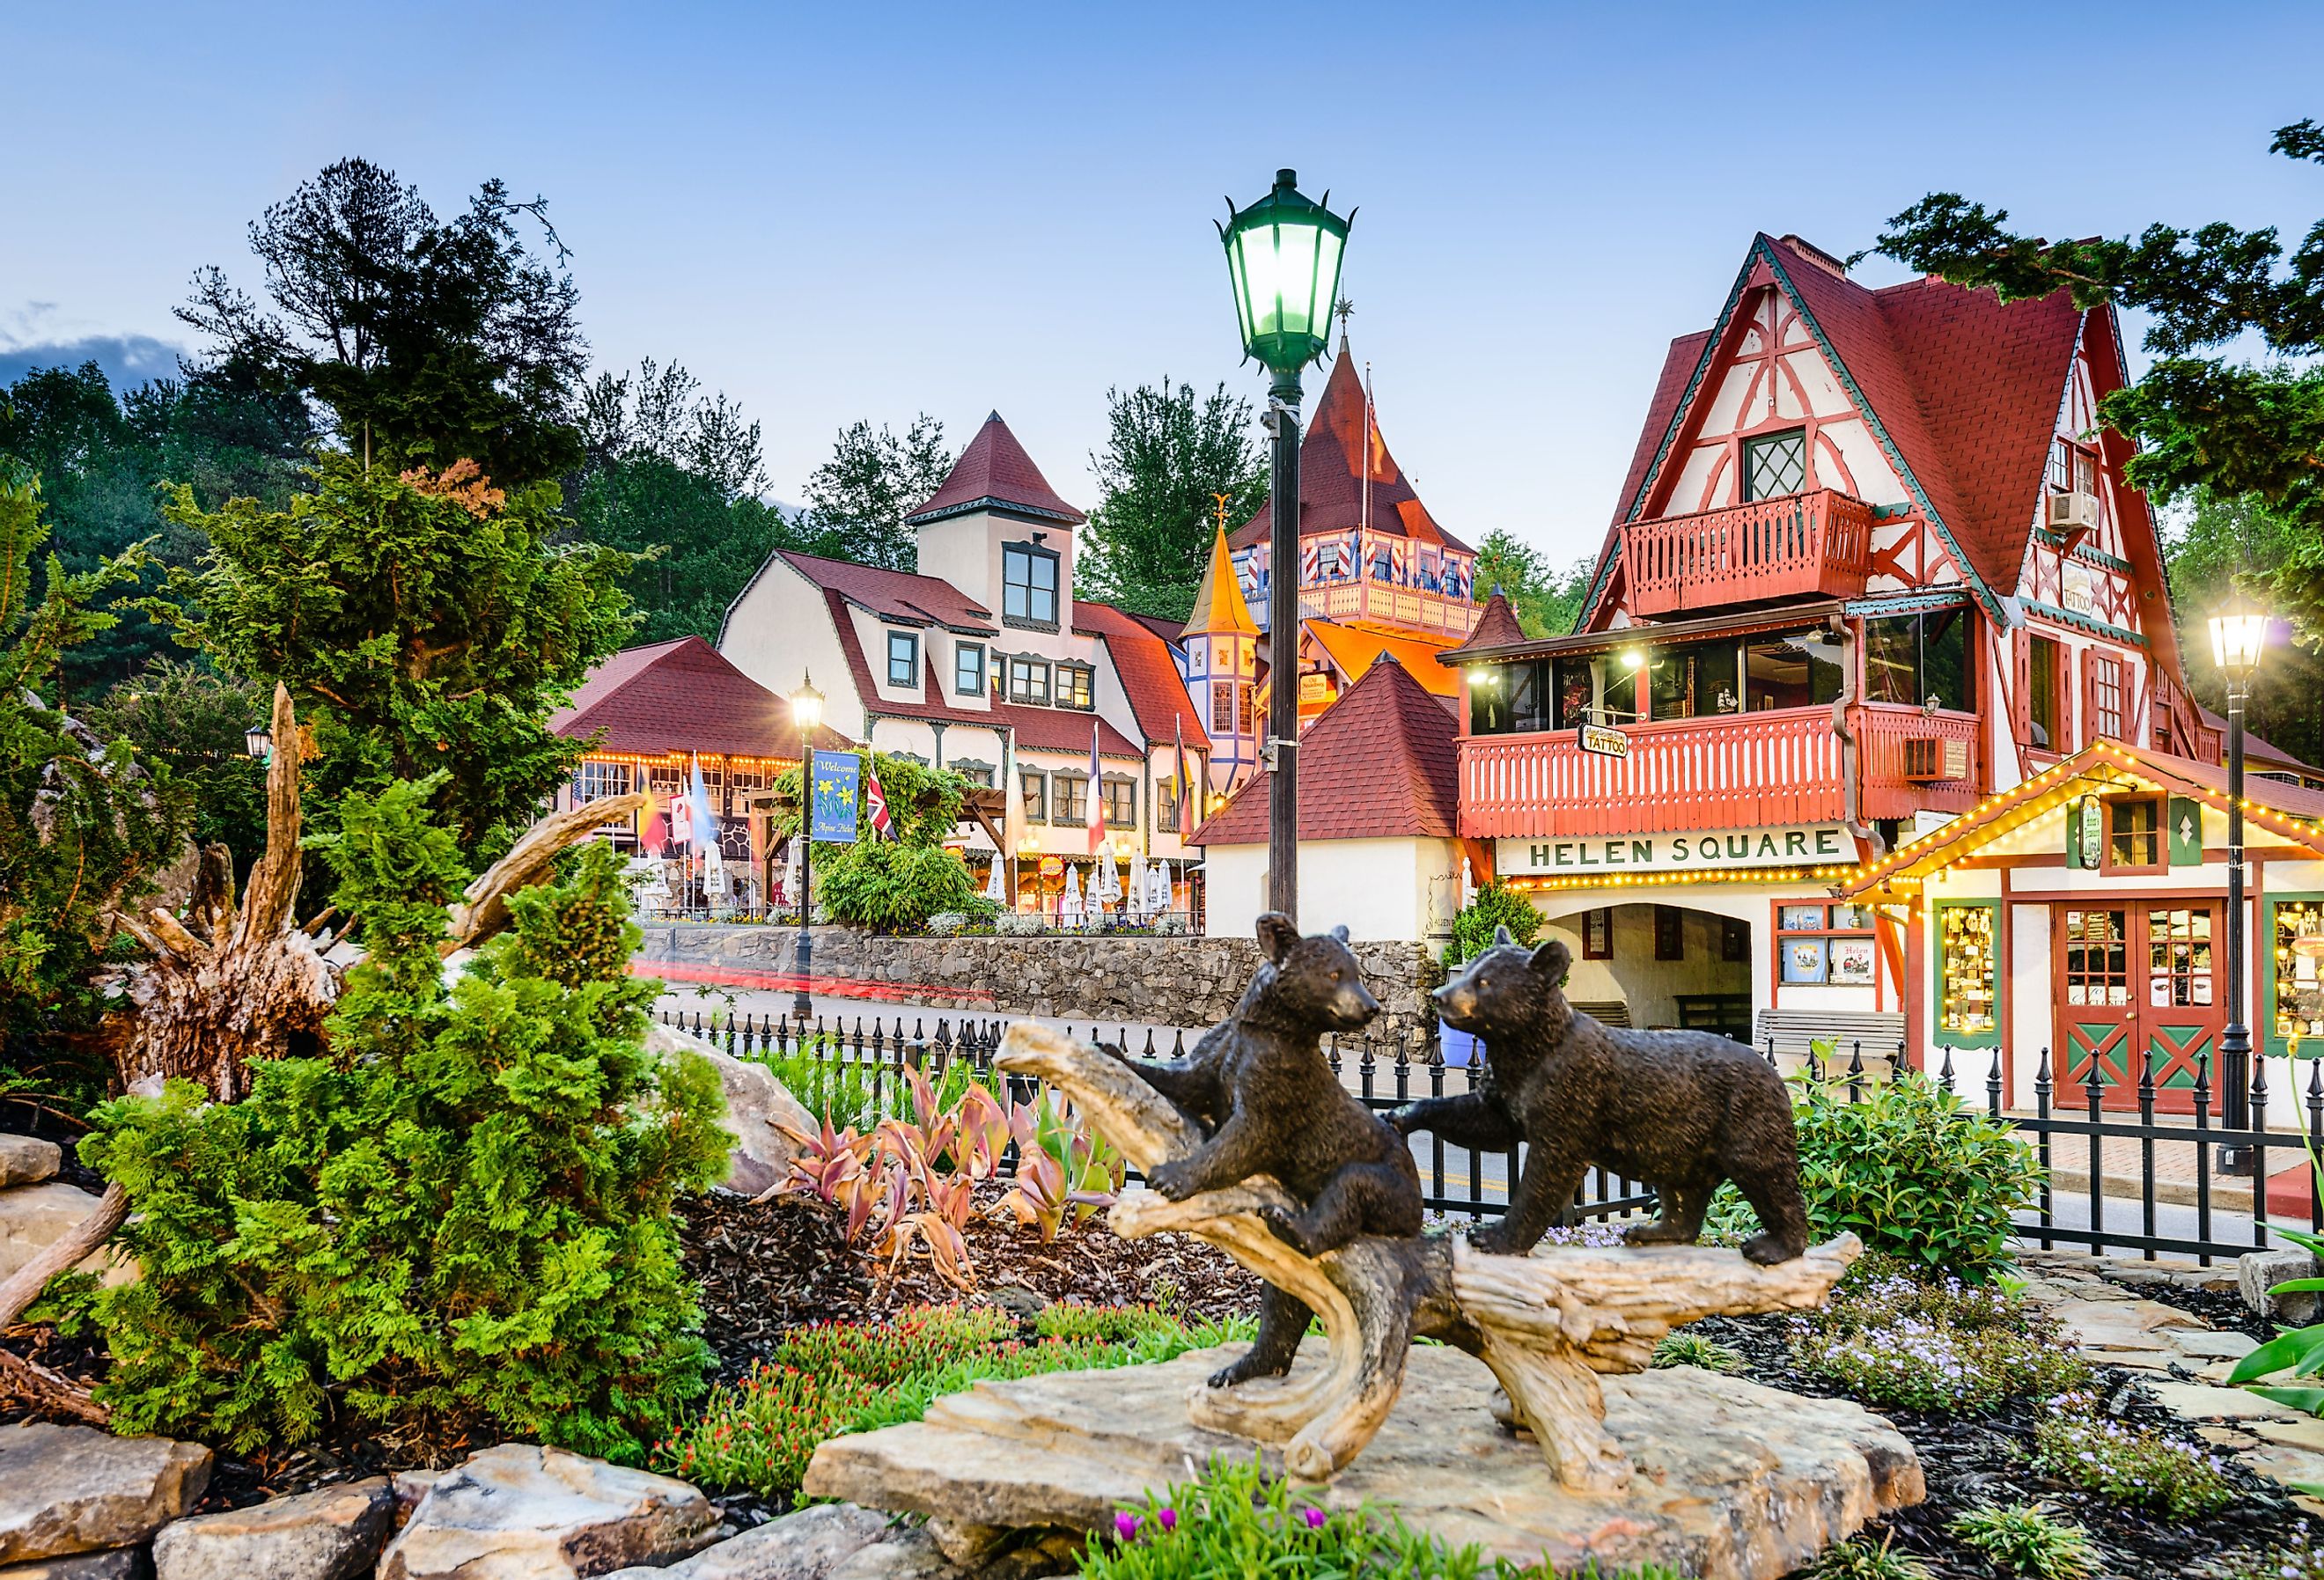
[1129,911,1420,1387]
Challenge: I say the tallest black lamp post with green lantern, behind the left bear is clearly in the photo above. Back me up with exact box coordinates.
[1217,170,1355,920]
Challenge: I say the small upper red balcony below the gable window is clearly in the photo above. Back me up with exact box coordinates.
[1622,488,1873,618]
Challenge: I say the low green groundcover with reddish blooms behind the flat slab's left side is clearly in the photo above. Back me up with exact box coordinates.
[653,1306,1257,1499]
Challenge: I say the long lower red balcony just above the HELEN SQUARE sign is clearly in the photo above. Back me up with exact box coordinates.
[1460,704,1980,839]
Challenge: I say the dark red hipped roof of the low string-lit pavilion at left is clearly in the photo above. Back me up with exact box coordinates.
[548,636,849,762]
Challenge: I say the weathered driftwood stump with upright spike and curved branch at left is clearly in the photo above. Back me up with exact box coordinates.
[105,686,646,1101]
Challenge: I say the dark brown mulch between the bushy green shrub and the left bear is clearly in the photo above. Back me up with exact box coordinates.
[679,1183,1260,1383]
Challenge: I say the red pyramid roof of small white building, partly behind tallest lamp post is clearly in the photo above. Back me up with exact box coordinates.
[1195,658,1460,846]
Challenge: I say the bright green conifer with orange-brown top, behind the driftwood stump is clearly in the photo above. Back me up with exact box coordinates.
[163,453,629,855]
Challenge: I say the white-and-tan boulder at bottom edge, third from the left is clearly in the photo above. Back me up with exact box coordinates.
[379,1443,718,1580]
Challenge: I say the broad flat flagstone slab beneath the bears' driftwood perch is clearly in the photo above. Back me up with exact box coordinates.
[806,1345,1924,1580]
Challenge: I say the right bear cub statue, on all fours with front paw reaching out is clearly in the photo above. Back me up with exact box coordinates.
[1387,927,1808,1264]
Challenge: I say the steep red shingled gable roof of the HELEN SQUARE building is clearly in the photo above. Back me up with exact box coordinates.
[1592,235,2103,627]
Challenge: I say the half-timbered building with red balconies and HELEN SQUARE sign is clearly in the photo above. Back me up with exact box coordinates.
[1443,235,2217,1055]
